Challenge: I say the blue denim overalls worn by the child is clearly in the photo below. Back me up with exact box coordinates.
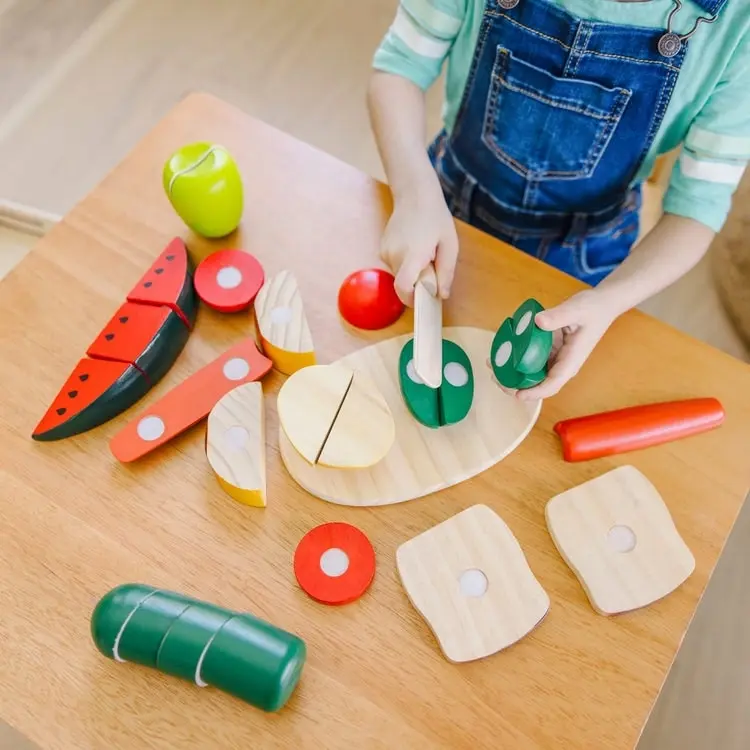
[429,0,726,285]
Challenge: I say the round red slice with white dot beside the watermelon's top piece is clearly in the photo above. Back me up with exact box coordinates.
[194,250,265,313]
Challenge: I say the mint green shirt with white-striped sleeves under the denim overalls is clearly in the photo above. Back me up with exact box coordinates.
[373,0,750,231]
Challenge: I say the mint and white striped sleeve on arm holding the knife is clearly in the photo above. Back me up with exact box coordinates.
[373,0,467,89]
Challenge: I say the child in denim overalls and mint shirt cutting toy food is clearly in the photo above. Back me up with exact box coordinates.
[369,0,750,399]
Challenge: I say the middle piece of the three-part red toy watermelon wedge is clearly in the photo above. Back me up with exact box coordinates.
[86,302,190,386]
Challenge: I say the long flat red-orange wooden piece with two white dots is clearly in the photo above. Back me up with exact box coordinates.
[109,338,271,463]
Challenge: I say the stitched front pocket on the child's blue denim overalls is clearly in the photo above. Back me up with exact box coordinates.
[482,47,632,180]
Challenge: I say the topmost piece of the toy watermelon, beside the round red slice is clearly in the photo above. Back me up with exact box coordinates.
[127,237,198,328]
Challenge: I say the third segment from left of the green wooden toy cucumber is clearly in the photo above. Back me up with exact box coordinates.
[156,604,233,680]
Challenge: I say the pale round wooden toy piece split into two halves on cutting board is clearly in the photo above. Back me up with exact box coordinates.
[276,364,395,468]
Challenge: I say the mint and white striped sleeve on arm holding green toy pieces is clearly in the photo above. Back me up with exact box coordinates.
[664,34,750,232]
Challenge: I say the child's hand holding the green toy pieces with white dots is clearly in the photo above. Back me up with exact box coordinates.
[516,289,617,401]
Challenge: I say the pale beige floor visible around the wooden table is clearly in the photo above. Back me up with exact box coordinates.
[0,0,750,750]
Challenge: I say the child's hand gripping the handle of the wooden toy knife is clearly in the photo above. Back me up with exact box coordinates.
[380,183,458,307]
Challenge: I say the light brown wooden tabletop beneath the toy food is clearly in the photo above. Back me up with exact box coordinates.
[0,94,750,750]
